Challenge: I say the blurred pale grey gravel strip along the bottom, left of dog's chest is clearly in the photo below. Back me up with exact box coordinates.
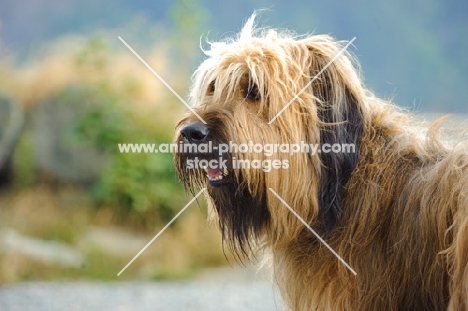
[0,281,282,311]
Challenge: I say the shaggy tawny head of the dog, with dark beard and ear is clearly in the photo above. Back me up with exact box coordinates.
[175,16,365,254]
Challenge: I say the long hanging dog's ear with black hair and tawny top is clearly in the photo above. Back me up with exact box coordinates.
[308,36,364,233]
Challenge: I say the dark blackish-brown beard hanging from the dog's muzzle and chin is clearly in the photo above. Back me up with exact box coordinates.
[175,133,270,260]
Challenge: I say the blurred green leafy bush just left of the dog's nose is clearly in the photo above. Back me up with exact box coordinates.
[71,85,181,223]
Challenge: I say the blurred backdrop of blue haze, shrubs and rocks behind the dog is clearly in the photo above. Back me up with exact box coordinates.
[0,0,468,308]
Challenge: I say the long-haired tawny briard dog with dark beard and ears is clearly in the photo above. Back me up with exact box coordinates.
[175,16,468,311]
